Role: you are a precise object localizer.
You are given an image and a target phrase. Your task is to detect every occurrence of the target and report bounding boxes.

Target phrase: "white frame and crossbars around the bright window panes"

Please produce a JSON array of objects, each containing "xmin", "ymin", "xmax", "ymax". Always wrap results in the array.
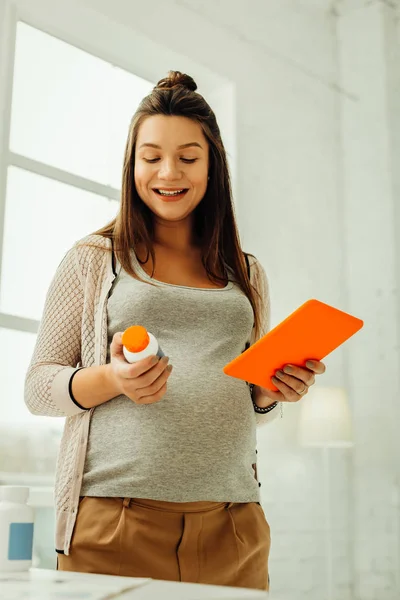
[{"xmin": 0, "ymin": 0, "xmax": 236, "ymax": 333}]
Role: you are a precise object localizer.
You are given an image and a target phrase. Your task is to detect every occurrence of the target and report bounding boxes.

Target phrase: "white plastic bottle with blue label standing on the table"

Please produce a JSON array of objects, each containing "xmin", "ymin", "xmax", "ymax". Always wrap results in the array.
[{"xmin": 0, "ymin": 485, "xmax": 34, "ymax": 573}]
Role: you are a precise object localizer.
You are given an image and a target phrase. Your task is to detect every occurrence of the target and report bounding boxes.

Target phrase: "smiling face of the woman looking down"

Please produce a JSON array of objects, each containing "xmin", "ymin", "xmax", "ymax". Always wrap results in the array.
[{"xmin": 135, "ymin": 115, "xmax": 208, "ymax": 221}]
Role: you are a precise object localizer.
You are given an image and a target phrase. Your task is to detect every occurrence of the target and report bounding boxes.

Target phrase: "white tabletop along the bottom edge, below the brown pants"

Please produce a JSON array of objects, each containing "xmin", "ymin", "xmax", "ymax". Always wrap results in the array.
[{"xmin": 0, "ymin": 569, "xmax": 269, "ymax": 600}]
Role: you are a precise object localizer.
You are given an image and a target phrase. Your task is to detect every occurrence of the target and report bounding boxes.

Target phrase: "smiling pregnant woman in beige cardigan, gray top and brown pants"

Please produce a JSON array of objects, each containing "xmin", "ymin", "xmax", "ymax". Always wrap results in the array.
[{"xmin": 25, "ymin": 72, "xmax": 325, "ymax": 590}]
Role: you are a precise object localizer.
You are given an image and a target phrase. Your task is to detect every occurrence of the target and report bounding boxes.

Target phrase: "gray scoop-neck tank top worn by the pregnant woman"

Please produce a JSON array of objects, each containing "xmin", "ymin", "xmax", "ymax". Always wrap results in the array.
[{"xmin": 81, "ymin": 255, "xmax": 259, "ymax": 502}]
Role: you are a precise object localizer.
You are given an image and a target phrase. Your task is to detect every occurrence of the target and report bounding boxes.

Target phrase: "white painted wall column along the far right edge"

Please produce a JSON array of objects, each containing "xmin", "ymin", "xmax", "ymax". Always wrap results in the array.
[{"xmin": 338, "ymin": 2, "xmax": 400, "ymax": 600}]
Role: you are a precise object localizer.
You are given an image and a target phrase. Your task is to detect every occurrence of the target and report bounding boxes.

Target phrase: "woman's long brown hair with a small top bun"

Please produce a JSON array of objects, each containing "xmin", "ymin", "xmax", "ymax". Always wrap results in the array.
[{"xmin": 95, "ymin": 71, "xmax": 260, "ymax": 332}]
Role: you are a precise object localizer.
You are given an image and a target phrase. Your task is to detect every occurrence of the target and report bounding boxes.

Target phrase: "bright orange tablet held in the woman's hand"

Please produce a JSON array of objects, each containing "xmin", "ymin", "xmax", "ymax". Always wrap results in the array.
[{"xmin": 223, "ymin": 300, "xmax": 364, "ymax": 391}]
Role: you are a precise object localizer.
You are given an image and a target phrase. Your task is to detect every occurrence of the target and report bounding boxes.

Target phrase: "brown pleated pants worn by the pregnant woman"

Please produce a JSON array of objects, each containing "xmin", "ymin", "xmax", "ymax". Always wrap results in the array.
[{"xmin": 58, "ymin": 497, "xmax": 270, "ymax": 590}]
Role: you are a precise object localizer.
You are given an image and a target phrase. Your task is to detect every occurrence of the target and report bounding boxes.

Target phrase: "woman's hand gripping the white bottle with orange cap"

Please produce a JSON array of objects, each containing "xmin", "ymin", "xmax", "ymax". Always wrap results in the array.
[{"xmin": 110, "ymin": 332, "xmax": 172, "ymax": 404}]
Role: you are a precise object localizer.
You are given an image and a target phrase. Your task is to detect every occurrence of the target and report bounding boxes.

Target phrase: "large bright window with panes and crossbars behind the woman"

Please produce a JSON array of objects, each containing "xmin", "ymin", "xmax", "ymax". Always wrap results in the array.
[{"xmin": 0, "ymin": 21, "xmax": 154, "ymax": 427}]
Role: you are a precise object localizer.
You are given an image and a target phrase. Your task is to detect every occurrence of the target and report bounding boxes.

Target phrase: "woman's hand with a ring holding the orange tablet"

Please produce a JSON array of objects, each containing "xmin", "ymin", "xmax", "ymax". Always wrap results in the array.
[{"xmin": 257, "ymin": 360, "xmax": 326, "ymax": 404}]
